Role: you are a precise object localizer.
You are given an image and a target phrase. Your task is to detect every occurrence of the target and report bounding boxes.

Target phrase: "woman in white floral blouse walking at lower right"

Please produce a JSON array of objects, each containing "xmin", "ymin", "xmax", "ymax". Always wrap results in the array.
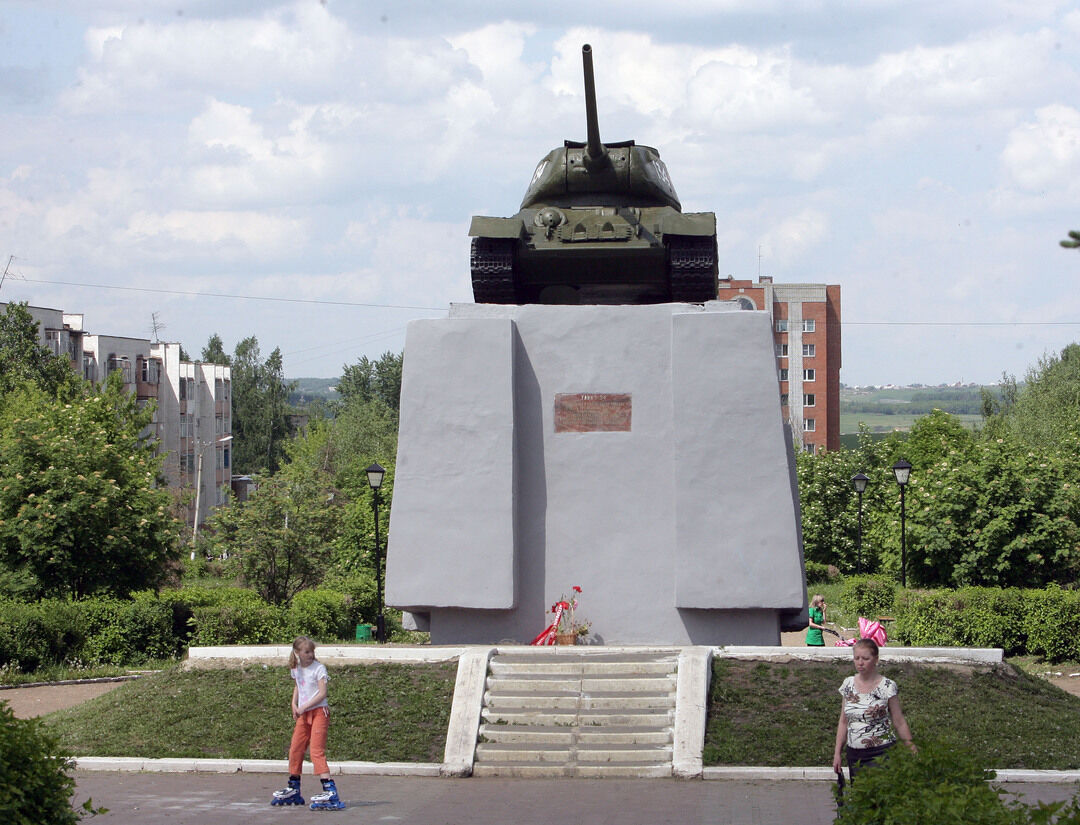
[{"xmin": 833, "ymin": 639, "xmax": 916, "ymax": 780}]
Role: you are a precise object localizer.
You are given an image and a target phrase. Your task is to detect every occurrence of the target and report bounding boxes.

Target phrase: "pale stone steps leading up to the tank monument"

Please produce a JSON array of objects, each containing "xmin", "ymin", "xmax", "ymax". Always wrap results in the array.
[{"xmin": 473, "ymin": 647, "xmax": 678, "ymax": 777}]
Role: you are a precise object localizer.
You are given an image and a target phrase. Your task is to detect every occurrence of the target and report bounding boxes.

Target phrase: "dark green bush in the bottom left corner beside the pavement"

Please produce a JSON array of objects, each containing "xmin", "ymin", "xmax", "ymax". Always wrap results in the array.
[{"xmin": 0, "ymin": 702, "xmax": 105, "ymax": 825}]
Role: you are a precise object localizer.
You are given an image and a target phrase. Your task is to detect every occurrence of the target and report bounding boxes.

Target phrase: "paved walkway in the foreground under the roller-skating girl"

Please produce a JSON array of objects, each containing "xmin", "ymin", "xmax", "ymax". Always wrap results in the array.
[{"xmin": 76, "ymin": 772, "xmax": 1075, "ymax": 825}]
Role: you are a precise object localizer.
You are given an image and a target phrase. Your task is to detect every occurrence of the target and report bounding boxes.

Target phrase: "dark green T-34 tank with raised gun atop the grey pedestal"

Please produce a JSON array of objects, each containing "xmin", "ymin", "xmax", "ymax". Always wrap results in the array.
[{"xmin": 469, "ymin": 44, "xmax": 717, "ymax": 303}]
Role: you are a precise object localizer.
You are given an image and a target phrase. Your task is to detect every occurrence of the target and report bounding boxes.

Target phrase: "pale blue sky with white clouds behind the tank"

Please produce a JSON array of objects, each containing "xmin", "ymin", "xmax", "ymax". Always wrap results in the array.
[{"xmin": 0, "ymin": 0, "xmax": 1080, "ymax": 384}]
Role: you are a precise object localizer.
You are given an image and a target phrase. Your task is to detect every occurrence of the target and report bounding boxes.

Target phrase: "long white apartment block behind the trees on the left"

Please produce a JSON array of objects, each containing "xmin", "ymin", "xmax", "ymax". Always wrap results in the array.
[{"xmin": 0, "ymin": 303, "xmax": 232, "ymax": 527}]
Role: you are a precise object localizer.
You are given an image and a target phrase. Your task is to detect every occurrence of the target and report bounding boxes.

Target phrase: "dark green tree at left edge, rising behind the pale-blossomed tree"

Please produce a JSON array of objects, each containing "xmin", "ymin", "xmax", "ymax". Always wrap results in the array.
[{"xmin": 0, "ymin": 302, "xmax": 79, "ymax": 400}]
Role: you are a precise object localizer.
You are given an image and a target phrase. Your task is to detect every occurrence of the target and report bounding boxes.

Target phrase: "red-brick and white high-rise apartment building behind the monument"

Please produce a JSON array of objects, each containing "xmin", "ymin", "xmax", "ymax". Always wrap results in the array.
[{"xmin": 718, "ymin": 275, "xmax": 840, "ymax": 452}]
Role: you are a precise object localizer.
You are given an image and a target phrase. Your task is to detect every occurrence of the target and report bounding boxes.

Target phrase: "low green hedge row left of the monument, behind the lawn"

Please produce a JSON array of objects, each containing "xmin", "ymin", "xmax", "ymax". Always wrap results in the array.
[{"xmin": 0, "ymin": 581, "xmax": 375, "ymax": 672}]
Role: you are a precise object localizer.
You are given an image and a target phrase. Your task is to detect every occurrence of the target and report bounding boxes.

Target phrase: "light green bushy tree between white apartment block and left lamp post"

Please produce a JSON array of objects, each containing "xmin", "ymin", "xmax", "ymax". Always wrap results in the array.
[{"xmin": 208, "ymin": 463, "xmax": 341, "ymax": 605}]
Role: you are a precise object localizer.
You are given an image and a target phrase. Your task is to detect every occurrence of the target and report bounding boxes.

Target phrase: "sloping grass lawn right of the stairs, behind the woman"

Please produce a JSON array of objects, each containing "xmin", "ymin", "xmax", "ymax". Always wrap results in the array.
[{"xmin": 704, "ymin": 659, "xmax": 1080, "ymax": 770}]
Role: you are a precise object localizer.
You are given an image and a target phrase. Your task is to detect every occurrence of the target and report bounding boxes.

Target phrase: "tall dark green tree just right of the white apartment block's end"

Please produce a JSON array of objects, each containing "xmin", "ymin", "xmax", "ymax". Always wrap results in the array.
[{"xmin": 230, "ymin": 336, "xmax": 292, "ymax": 473}]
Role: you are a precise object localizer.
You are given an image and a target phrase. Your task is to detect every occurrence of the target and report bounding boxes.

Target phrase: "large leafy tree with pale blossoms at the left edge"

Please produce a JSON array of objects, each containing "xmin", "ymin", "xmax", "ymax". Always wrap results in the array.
[{"xmin": 0, "ymin": 374, "xmax": 178, "ymax": 598}]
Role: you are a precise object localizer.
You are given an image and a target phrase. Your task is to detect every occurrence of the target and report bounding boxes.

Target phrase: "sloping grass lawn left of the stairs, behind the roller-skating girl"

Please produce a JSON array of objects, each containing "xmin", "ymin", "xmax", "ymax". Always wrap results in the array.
[{"xmin": 44, "ymin": 662, "xmax": 457, "ymax": 762}]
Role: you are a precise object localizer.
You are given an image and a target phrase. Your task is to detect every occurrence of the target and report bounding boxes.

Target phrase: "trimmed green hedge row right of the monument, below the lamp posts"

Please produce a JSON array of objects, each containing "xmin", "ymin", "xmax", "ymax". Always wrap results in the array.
[{"xmin": 825, "ymin": 576, "xmax": 1080, "ymax": 662}]
